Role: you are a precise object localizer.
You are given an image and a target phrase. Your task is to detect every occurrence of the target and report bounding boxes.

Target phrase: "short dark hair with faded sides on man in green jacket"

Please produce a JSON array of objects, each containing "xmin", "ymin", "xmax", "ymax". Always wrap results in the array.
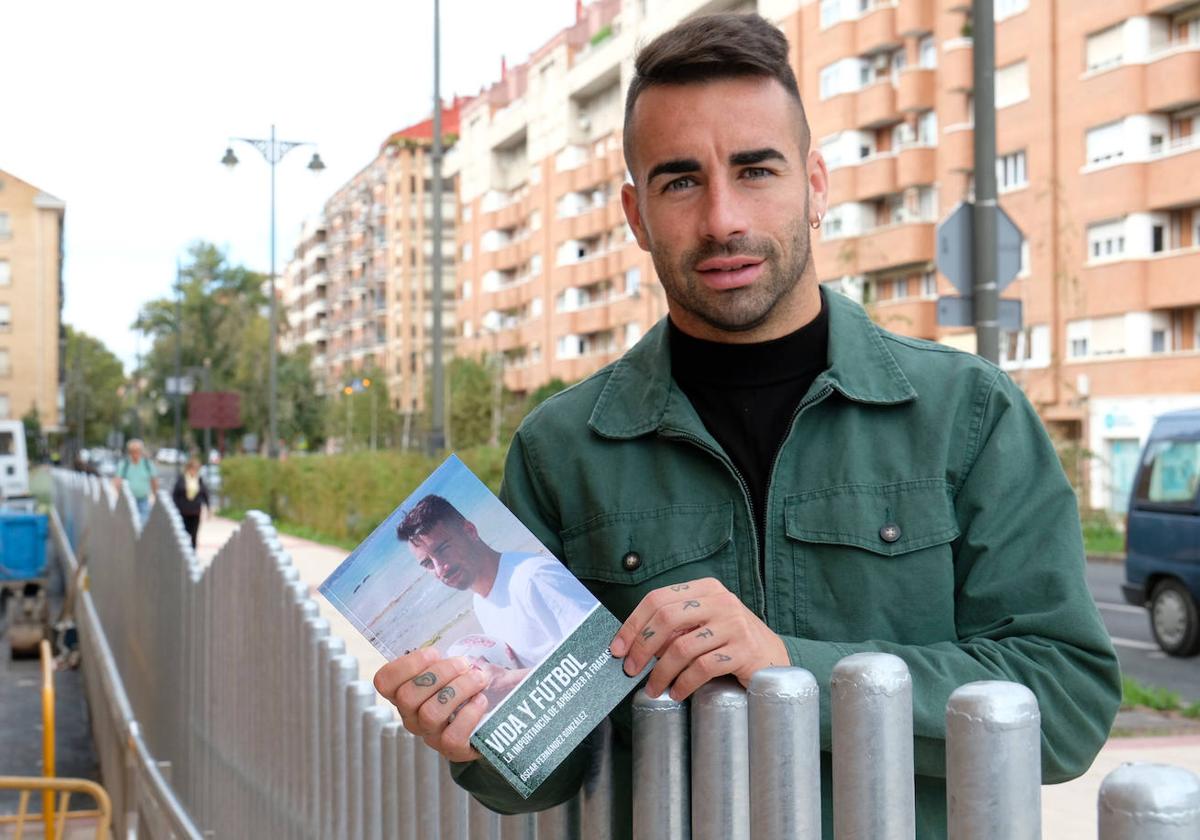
[{"xmin": 624, "ymin": 13, "xmax": 810, "ymax": 172}]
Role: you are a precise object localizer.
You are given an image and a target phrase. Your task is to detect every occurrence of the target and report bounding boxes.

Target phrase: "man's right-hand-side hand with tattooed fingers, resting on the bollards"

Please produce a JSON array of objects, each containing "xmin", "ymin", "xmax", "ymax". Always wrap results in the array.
[{"xmin": 612, "ymin": 577, "xmax": 790, "ymax": 701}]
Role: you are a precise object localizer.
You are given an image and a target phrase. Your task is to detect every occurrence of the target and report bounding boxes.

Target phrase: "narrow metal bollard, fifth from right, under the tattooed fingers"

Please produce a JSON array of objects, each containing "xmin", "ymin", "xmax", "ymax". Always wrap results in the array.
[{"xmin": 691, "ymin": 677, "xmax": 750, "ymax": 840}]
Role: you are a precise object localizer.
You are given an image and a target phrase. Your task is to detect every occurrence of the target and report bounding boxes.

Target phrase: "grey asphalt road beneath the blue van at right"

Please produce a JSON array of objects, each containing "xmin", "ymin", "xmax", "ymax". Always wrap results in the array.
[{"xmin": 1087, "ymin": 562, "xmax": 1200, "ymax": 703}]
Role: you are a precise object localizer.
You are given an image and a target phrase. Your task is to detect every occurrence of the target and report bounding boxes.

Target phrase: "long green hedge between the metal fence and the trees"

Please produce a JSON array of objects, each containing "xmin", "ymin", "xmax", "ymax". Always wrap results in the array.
[{"xmin": 221, "ymin": 446, "xmax": 505, "ymax": 542}]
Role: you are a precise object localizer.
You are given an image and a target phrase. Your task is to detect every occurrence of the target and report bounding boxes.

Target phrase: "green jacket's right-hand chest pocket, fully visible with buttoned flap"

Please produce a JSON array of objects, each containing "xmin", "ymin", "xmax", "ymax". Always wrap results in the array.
[{"xmin": 784, "ymin": 479, "xmax": 959, "ymax": 644}]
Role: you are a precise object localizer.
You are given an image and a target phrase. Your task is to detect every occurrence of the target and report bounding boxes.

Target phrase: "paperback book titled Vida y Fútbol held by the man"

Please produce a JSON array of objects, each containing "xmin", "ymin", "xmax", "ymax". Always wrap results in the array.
[{"xmin": 319, "ymin": 455, "xmax": 649, "ymax": 798}]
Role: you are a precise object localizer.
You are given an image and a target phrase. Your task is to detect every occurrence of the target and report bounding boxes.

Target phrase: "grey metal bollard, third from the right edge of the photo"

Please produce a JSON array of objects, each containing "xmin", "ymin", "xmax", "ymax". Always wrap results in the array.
[{"xmin": 829, "ymin": 653, "xmax": 917, "ymax": 840}]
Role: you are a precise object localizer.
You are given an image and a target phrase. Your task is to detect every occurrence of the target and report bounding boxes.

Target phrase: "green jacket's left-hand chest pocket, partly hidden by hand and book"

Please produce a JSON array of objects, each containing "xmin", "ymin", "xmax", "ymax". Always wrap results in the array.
[{"xmin": 560, "ymin": 502, "xmax": 737, "ymax": 620}]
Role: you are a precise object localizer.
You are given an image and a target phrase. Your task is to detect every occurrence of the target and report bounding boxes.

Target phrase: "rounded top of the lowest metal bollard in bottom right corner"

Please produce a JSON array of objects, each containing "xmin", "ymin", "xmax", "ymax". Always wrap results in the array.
[{"xmin": 1099, "ymin": 764, "xmax": 1200, "ymax": 840}]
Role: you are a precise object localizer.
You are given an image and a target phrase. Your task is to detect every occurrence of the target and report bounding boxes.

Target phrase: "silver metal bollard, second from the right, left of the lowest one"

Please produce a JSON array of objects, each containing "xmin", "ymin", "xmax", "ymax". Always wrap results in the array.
[{"xmin": 946, "ymin": 680, "xmax": 1042, "ymax": 840}]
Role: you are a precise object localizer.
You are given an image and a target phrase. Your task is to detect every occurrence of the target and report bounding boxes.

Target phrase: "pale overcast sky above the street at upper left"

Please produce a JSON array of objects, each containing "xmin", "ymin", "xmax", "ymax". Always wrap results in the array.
[{"xmin": 0, "ymin": 0, "xmax": 575, "ymax": 370}]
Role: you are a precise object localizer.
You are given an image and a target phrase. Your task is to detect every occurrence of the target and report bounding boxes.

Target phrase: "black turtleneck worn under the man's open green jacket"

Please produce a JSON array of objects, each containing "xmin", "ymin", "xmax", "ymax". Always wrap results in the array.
[{"xmin": 670, "ymin": 295, "xmax": 829, "ymax": 564}]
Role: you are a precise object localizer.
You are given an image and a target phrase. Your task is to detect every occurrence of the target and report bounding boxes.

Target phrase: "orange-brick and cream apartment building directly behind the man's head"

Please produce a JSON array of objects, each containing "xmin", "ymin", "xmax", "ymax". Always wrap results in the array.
[{"xmin": 454, "ymin": 0, "xmax": 1200, "ymax": 510}]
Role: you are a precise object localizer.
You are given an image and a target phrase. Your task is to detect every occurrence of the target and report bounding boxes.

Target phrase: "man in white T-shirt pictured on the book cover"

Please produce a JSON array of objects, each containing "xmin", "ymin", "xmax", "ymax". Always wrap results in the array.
[{"xmin": 396, "ymin": 494, "xmax": 595, "ymax": 702}]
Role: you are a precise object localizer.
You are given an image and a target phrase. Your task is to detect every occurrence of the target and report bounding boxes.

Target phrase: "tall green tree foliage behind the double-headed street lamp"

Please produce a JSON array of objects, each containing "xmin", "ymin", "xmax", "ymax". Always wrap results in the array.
[{"xmin": 133, "ymin": 242, "xmax": 325, "ymax": 448}]
